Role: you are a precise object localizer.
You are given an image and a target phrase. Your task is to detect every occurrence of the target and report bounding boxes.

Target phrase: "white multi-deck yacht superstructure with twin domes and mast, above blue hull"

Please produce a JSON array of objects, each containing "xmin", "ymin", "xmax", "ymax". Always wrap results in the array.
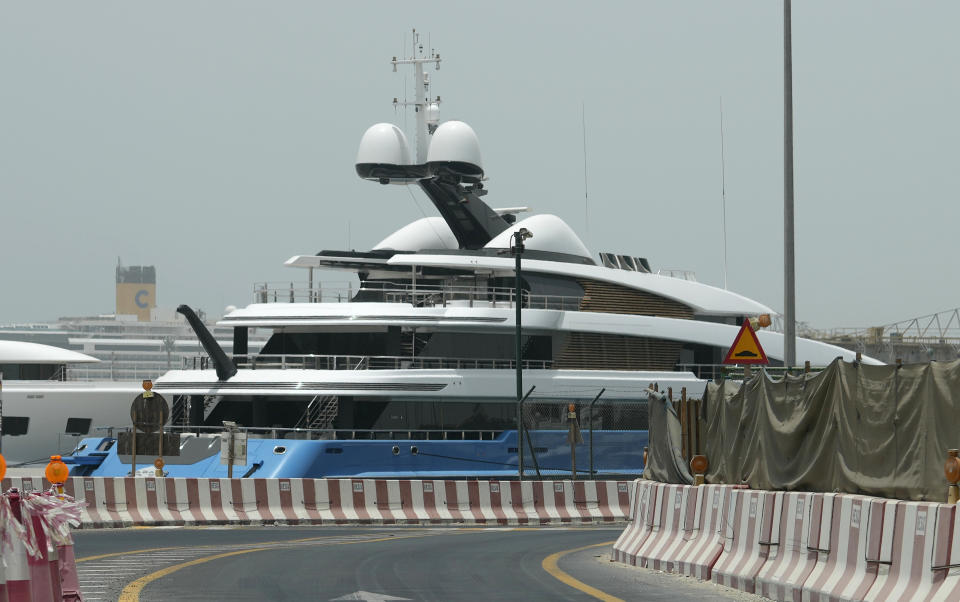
[{"xmin": 156, "ymin": 32, "xmax": 872, "ymax": 446}]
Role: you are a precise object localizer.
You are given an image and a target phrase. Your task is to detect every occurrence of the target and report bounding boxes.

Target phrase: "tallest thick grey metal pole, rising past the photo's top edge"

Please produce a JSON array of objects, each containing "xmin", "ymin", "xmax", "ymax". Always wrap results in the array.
[{"xmin": 783, "ymin": 0, "xmax": 797, "ymax": 368}]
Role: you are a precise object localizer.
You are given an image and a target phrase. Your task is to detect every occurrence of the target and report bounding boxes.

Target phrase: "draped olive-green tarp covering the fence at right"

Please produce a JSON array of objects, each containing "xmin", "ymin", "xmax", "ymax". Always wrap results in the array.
[{"xmin": 649, "ymin": 359, "xmax": 960, "ymax": 501}]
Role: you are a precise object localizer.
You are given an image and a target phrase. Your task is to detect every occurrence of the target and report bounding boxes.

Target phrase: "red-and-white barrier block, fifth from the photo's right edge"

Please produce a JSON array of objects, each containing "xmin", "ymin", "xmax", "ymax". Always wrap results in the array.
[{"xmin": 711, "ymin": 489, "xmax": 775, "ymax": 593}]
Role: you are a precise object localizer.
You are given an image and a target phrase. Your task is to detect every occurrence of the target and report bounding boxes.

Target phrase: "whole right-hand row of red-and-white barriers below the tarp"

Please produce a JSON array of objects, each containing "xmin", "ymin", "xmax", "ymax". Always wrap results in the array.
[{"xmin": 612, "ymin": 481, "xmax": 960, "ymax": 601}]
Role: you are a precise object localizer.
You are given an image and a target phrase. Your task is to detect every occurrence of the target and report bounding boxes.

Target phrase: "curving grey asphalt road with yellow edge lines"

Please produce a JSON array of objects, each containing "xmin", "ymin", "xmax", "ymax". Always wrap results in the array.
[{"xmin": 75, "ymin": 527, "xmax": 760, "ymax": 602}]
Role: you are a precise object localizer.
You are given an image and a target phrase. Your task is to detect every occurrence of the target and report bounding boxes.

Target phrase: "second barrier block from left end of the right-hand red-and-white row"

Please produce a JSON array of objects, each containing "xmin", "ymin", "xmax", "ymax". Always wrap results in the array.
[{"xmin": 636, "ymin": 485, "xmax": 697, "ymax": 572}]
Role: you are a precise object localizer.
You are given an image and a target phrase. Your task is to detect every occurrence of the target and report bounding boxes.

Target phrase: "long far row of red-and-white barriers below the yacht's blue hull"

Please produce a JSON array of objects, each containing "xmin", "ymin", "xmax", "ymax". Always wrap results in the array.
[{"xmin": 3, "ymin": 477, "xmax": 630, "ymax": 528}]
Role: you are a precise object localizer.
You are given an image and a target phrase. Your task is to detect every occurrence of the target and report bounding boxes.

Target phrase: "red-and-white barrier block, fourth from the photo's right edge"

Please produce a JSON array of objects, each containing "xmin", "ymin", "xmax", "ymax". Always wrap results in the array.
[{"xmin": 757, "ymin": 492, "xmax": 820, "ymax": 602}]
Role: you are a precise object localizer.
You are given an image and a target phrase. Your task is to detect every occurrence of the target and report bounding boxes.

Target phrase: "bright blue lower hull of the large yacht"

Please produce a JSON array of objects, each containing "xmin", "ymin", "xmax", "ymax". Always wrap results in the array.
[{"xmin": 64, "ymin": 431, "xmax": 648, "ymax": 479}]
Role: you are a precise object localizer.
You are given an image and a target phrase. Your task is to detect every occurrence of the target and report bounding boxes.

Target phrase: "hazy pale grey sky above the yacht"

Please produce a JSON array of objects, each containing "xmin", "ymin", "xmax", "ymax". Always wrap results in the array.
[{"xmin": 0, "ymin": 0, "xmax": 960, "ymax": 328}]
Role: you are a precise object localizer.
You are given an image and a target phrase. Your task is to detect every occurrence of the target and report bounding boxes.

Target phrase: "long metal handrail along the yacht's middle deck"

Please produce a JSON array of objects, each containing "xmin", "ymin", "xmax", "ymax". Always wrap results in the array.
[{"xmin": 182, "ymin": 354, "xmax": 553, "ymax": 370}]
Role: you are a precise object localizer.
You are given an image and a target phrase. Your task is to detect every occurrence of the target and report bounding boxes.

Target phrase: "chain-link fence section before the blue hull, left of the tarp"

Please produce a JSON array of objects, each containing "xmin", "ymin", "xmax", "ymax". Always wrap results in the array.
[{"xmin": 518, "ymin": 399, "xmax": 648, "ymax": 479}]
